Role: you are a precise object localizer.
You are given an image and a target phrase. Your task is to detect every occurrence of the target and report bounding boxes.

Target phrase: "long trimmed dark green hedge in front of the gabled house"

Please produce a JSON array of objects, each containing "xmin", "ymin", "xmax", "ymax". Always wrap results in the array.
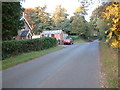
[{"xmin": 2, "ymin": 37, "xmax": 57, "ymax": 60}]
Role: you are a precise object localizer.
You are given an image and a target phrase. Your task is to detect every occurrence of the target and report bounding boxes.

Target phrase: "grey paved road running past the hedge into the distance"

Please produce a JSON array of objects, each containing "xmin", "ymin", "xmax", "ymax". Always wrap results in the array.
[{"xmin": 2, "ymin": 41, "xmax": 100, "ymax": 88}]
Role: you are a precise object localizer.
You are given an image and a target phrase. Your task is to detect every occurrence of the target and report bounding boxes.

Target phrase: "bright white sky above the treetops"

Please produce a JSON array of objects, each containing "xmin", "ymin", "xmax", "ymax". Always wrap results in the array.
[{"xmin": 22, "ymin": 0, "xmax": 99, "ymax": 21}]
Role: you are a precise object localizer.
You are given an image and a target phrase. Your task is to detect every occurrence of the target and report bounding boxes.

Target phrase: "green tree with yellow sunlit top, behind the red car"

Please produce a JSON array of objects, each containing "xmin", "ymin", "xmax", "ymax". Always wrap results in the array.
[{"xmin": 70, "ymin": 7, "xmax": 88, "ymax": 38}]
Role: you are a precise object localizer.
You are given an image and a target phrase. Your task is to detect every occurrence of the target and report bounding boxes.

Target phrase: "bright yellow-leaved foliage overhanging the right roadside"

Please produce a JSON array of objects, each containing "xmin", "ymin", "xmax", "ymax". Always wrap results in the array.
[{"xmin": 91, "ymin": 2, "xmax": 120, "ymax": 48}]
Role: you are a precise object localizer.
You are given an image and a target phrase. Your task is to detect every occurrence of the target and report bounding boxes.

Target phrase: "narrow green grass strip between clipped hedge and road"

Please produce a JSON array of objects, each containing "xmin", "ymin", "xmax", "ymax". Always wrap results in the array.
[{"xmin": 0, "ymin": 46, "xmax": 63, "ymax": 70}]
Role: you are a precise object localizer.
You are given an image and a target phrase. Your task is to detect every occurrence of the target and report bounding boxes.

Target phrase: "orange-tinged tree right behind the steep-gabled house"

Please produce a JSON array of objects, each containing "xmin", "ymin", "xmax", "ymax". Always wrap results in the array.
[{"xmin": 25, "ymin": 6, "xmax": 52, "ymax": 34}]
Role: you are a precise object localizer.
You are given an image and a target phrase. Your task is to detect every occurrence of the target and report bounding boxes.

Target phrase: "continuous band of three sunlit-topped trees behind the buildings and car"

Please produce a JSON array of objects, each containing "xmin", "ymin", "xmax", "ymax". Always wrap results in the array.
[{"xmin": 25, "ymin": 5, "xmax": 94, "ymax": 37}]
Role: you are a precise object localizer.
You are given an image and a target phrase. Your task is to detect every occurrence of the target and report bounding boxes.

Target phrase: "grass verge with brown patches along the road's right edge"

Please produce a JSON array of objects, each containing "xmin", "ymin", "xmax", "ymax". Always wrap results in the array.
[{"xmin": 100, "ymin": 42, "xmax": 118, "ymax": 88}]
